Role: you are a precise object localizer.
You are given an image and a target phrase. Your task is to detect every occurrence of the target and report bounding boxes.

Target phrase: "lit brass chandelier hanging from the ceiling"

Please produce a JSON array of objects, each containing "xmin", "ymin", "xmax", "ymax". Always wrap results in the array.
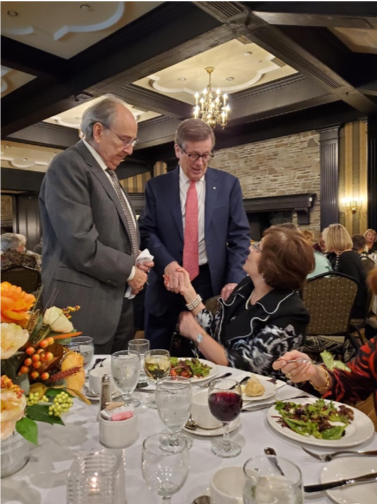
[{"xmin": 194, "ymin": 67, "xmax": 230, "ymax": 129}]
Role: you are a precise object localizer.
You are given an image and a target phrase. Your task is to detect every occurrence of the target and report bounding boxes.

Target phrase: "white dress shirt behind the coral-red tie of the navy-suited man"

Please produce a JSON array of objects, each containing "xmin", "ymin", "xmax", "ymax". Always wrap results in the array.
[{"xmin": 179, "ymin": 167, "xmax": 208, "ymax": 266}]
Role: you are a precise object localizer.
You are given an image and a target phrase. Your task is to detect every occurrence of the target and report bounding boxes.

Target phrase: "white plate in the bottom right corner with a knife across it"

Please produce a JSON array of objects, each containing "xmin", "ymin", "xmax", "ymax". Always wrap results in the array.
[{"xmin": 320, "ymin": 456, "xmax": 377, "ymax": 504}]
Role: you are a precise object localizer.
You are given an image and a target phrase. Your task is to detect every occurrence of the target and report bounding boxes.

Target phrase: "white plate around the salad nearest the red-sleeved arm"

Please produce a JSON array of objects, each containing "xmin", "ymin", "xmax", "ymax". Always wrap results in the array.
[{"xmin": 267, "ymin": 397, "xmax": 377, "ymax": 446}]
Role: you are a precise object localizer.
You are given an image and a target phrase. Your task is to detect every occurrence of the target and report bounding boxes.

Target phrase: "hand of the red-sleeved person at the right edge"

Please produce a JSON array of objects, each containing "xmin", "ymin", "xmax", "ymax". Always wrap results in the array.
[{"xmin": 272, "ymin": 350, "xmax": 322, "ymax": 383}]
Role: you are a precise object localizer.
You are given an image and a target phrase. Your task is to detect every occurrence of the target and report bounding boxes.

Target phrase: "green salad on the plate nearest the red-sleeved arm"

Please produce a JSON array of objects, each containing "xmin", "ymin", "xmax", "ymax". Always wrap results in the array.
[{"xmin": 275, "ymin": 399, "xmax": 353, "ymax": 440}]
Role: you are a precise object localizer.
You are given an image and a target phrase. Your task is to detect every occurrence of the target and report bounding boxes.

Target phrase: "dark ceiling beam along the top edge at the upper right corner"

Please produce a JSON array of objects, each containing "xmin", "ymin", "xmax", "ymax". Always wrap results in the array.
[{"xmin": 241, "ymin": 1, "xmax": 377, "ymax": 29}]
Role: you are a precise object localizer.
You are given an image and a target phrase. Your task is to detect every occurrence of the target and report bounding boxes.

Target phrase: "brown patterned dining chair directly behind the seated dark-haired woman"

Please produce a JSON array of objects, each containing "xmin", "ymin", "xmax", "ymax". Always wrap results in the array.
[{"xmin": 302, "ymin": 271, "xmax": 361, "ymax": 362}]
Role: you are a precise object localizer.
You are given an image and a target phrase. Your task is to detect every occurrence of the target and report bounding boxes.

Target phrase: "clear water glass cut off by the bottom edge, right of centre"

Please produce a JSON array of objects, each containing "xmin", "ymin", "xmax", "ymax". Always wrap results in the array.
[{"xmin": 243, "ymin": 455, "xmax": 304, "ymax": 504}]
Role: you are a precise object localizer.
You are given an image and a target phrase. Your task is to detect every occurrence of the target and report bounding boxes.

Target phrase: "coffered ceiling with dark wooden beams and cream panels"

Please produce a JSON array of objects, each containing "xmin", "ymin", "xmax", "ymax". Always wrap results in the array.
[{"xmin": 0, "ymin": 1, "xmax": 377, "ymax": 189}]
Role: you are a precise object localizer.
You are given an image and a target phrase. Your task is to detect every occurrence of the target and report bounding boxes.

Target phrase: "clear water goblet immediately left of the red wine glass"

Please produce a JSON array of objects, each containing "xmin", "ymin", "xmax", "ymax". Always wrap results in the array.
[{"xmin": 156, "ymin": 376, "xmax": 192, "ymax": 451}]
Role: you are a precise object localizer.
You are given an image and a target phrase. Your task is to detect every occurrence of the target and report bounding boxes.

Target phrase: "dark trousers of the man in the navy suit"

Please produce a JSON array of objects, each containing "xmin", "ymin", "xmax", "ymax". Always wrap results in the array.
[{"xmin": 145, "ymin": 264, "xmax": 214, "ymax": 350}]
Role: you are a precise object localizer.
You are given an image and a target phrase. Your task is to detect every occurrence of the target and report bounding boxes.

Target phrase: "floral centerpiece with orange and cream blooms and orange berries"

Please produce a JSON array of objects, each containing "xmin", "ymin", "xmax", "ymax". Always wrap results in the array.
[{"xmin": 0, "ymin": 282, "xmax": 88, "ymax": 444}]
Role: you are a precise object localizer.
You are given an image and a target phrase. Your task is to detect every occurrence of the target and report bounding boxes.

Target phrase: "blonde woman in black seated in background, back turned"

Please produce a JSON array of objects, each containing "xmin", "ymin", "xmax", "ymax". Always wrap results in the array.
[{"xmin": 323, "ymin": 224, "xmax": 368, "ymax": 318}]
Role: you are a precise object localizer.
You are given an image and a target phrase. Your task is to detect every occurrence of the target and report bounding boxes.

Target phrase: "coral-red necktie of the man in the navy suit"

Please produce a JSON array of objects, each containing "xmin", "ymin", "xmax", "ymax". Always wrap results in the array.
[{"xmin": 183, "ymin": 180, "xmax": 199, "ymax": 281}]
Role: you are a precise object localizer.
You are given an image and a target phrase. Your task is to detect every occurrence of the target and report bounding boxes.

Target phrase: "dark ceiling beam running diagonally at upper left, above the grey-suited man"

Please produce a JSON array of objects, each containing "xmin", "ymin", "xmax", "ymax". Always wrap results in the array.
[{"xmin": 0, "ymin": 1, "xmax": 223, "ymax": 138}]
